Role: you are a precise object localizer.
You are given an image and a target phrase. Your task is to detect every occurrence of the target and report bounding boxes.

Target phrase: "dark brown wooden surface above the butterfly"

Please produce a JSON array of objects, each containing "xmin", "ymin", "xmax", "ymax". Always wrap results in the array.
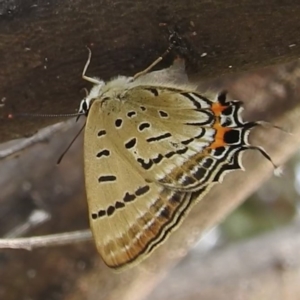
[{"xmin": 0, "ymin": 0, "xmax": 300, "ymax": 142}]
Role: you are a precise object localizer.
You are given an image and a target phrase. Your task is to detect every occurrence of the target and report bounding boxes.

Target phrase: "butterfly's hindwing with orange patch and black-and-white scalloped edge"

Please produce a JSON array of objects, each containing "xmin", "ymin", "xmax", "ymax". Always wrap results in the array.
[{"xmin": 124, "ymin": 86, "xmax": 256, "ymax": 192}]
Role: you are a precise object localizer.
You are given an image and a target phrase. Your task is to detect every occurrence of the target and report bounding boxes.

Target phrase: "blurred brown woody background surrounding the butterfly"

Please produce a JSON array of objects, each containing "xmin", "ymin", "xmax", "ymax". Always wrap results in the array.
[{"xmin": 0, "ymin": 0, "xmax": 300, "ymax": 300}]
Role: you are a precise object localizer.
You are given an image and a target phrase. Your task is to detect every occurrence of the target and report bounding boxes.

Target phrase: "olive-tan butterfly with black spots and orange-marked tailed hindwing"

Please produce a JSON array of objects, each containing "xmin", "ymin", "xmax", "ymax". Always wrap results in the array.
[{"xmin": 79, "ymin": 45, "xmax": 272, "ymax": 269}]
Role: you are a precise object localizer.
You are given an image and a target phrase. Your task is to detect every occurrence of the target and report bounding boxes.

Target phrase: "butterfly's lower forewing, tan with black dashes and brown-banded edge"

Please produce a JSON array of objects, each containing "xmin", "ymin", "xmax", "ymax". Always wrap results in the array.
[{"xmin": 84, "ymin": 101, "xmax": 206, "ymax": 268}]
